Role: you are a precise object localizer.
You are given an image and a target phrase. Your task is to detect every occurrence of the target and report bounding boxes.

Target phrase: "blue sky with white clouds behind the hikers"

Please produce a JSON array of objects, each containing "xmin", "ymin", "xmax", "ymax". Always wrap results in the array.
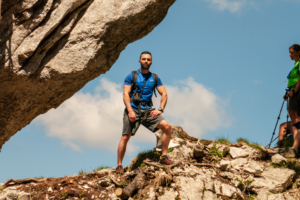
[{"xmin": 0, "ymin": 0, "xmax": 300, "ymax": 182}]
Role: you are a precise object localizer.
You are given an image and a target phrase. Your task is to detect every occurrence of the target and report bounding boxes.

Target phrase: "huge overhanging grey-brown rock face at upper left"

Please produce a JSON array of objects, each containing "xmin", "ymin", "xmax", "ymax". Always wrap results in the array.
[{"xmin": 0, "ymin": 0, "xmax": 175, "ymax": 150}]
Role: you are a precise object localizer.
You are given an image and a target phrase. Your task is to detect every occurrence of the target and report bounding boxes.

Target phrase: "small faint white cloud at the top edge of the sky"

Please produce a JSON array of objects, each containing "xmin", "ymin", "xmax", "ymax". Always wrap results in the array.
[{"xmin": 206, "ymin": 0, "xmax": 248, "ymax": 12}]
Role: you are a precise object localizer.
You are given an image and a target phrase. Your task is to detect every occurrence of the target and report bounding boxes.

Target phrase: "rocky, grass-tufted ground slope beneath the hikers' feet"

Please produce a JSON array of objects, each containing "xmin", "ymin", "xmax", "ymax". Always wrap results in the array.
[{"xmin": 0, "ymin": 126, "xmax": 300, "ymax": 200}]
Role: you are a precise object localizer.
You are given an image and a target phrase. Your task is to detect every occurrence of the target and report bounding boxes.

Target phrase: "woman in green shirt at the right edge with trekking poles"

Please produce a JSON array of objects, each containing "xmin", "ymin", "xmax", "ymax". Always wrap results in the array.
[{"xmin": 284, "ymin": 44, "xmax": 300, "ymax": 158}]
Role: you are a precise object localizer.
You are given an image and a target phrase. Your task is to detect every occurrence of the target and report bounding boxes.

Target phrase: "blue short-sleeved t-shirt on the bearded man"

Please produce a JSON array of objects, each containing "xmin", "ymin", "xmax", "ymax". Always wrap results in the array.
[{"xmin": 124, "ymin": 70, "xmax": 163, "ymax": 110}]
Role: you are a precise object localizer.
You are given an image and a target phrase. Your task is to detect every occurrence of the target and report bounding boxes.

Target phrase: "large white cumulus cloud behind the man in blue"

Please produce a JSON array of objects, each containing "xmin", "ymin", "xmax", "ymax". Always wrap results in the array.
[{"xmin": 35, "ymin": 78, "xmax": 231, "ymax": 152}]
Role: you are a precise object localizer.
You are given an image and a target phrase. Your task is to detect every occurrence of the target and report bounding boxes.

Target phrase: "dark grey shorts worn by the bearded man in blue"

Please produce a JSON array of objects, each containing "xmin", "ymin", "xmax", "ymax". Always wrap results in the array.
[{"xmin": 122, "ymin": 109, "xmax": 164, "ymax": 136}]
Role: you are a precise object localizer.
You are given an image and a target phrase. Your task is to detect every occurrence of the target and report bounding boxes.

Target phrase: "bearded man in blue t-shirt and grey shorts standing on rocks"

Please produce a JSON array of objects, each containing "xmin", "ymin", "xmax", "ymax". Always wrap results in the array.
[{"xmin": 116, "ymin": 51, "xmax": 173, "ymax": 174}]
